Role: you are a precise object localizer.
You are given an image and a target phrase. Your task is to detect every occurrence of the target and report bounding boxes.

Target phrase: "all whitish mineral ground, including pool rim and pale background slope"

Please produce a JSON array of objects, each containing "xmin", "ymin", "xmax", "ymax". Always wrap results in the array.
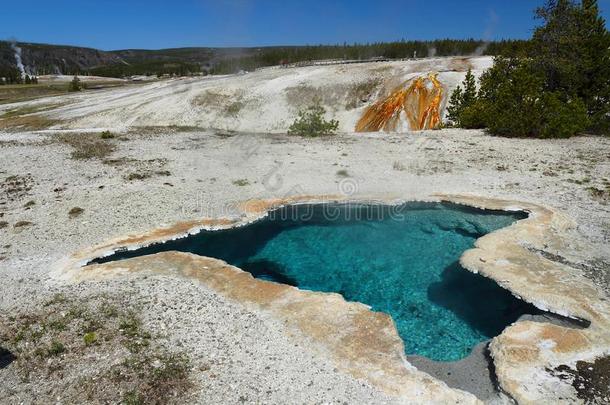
[{"xmin": 0, "ymin": 58, "xmax": 610, "ymax": 403}]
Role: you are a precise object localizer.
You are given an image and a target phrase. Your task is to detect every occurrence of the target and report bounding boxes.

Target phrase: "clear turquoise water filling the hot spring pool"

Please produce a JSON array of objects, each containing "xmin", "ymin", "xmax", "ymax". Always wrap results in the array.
[{"xmin": 92, "ymin": 203, "xmax": 535, "ymax": 361}]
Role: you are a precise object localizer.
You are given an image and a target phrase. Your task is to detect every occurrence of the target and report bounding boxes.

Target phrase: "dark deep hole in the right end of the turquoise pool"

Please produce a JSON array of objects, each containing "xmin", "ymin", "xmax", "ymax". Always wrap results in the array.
[{"xmin": 428, "ymin": 262, "xmax": 541, "ymax": 338}]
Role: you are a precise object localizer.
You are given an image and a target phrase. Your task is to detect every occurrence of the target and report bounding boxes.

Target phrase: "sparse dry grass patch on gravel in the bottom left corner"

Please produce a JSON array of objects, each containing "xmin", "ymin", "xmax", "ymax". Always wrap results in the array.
[{"xmin": 0, "ymin": 294, "xmax": 193, "ymax": 404}]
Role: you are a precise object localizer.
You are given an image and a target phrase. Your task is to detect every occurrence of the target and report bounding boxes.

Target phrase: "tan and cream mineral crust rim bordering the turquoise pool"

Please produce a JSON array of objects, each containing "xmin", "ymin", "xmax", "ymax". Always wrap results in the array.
[{"xmin": 51, "ymin": 194, "xmax": 610, "ymax": 403}]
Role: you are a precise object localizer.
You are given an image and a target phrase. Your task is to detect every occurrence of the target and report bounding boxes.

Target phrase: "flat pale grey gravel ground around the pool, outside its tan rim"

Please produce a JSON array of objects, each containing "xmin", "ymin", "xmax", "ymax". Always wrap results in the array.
[{"xmin": 0, "ymin": 130, "xmax": 610, "ymax": 403}]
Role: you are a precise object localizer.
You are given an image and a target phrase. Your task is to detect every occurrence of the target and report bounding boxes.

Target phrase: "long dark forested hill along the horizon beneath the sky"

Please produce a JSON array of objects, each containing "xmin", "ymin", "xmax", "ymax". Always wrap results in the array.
[{"xmin": 0, "ymin": 39, "xmax": 529, "ymax": 77}]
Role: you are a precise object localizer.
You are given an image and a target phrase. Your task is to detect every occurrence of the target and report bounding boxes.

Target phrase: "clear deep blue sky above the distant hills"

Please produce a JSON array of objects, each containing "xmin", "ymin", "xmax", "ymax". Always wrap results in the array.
[{"xmin": 0, "ymin": 0, "xmax": 610, "ymax": 50}]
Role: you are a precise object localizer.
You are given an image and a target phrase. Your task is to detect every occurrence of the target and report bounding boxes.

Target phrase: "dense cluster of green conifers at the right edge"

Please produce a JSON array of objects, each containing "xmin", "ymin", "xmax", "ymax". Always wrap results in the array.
[{"xmin": 447, "ymin": 0, "xmax": 610, "ymax": 138}]
